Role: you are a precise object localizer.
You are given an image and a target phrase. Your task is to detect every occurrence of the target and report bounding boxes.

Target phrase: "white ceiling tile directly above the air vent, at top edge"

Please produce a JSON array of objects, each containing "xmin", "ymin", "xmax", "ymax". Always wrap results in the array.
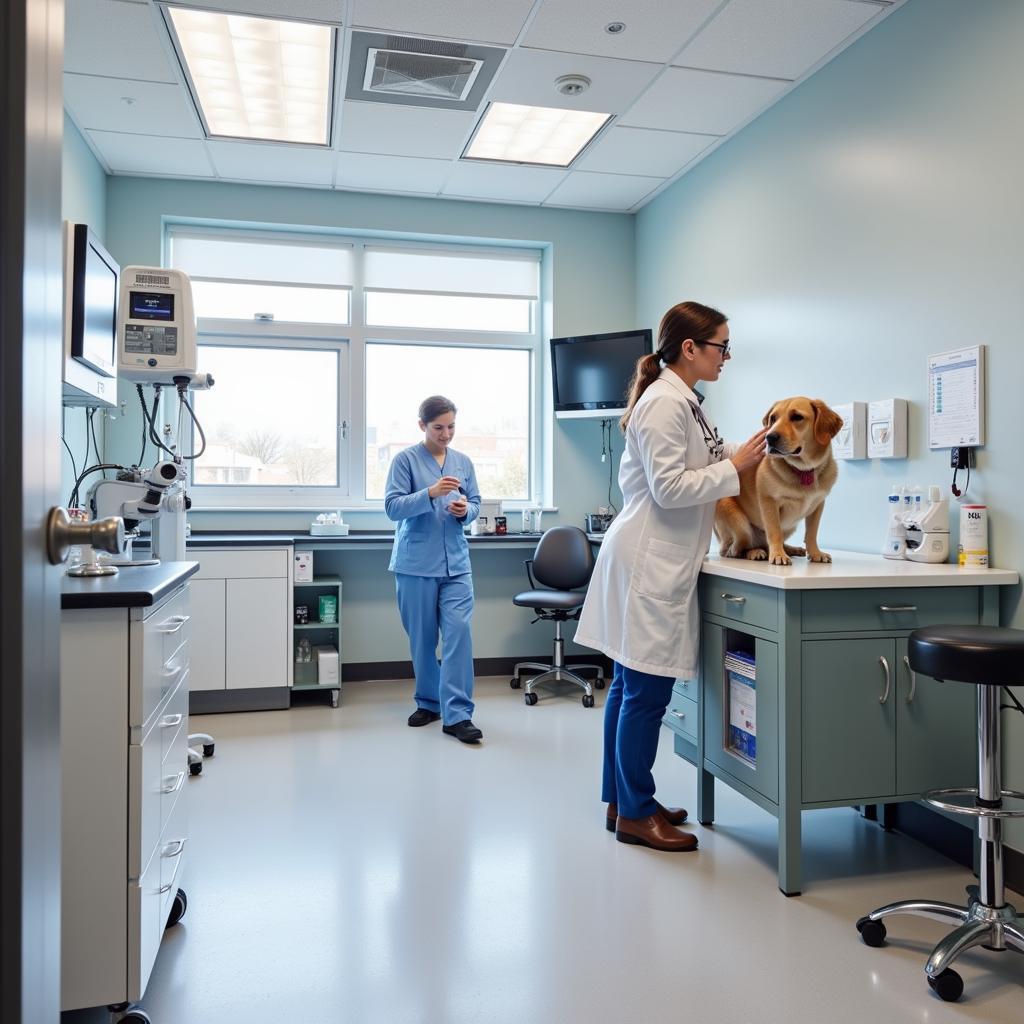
[{"xmin": 352, "ymin": 0, "xmax": 534, "ymax": 46}]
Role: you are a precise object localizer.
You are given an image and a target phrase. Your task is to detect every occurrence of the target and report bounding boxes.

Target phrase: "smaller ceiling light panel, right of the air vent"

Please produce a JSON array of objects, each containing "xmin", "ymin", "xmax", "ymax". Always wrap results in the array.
[{"xmin": 463, "ymin": 103, "xmax": 611, "ymax": 167}]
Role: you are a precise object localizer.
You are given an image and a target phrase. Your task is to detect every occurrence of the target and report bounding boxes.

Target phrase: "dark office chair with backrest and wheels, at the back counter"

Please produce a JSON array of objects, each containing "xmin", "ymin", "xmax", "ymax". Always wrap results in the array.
[{"xmin": 509, "ymin": 526, "xmax": 604, "ymax": 708}]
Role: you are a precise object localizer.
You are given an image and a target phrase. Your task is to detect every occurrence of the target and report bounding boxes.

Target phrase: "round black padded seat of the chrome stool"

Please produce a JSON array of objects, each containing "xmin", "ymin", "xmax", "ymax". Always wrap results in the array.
[{"xmin": 907, "ymin": 626, "xmax": 1024, "ymax": 686}]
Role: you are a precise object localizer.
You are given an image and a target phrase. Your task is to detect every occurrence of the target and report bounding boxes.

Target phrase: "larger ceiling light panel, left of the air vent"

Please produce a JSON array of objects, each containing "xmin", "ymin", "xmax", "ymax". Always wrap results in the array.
[{"xmin": 167, "ymin": 7, "xmax": 334, "ymax": 145}]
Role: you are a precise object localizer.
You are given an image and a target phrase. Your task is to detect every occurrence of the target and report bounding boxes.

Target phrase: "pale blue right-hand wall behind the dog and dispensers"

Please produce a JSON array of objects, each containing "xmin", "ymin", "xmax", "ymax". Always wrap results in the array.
[{"xmin": 637, "ymin": 0, "xmax": 1024, "ymax": 849}]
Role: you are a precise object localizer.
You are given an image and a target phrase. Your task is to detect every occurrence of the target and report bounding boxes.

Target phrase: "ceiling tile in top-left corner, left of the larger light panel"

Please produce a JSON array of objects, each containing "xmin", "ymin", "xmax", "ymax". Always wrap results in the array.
[{"xmin": 63, "ymin": 0, "xmax": 178, "ymax": 83}]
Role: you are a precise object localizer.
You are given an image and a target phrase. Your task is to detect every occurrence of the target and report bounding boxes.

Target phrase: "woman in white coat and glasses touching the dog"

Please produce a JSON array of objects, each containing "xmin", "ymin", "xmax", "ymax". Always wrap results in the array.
[{"xmin": 575, "ymin": 302, "xmax": 766, "ymax": 851}]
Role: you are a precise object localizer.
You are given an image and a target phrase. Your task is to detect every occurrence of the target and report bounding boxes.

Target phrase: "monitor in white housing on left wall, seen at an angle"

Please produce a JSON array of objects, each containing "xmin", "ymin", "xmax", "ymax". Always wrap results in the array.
[{"xmin": 63, "ymin": 221, "xmax": 121, "ymax": 404}]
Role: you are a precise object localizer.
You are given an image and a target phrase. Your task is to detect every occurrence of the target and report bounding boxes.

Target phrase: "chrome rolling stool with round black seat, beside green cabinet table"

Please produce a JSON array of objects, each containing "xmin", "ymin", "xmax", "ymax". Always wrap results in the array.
[{"xmin": 857, "ymin": 626, "xmax": 1024, "ymax": 1002}]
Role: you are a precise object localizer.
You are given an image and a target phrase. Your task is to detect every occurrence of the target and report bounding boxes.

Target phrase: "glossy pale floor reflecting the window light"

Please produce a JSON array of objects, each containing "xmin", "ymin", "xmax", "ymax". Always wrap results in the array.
[{"xmin": 70, "ymin": 679, "xmax": 1024, "ymax": 1024}]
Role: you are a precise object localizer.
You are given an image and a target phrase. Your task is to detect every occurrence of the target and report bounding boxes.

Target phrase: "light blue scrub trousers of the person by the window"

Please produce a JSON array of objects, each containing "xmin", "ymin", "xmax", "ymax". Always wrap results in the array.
[{"xmin": 394, "ymin": 572, "xmax": 473, "ymax": 725}]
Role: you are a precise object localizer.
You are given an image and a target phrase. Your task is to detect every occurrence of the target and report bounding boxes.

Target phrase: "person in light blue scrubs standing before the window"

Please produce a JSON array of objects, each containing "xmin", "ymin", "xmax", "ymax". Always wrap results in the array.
[{"xmin": 384, "ymin": 395, "xmax": 483, "ymax": 743}]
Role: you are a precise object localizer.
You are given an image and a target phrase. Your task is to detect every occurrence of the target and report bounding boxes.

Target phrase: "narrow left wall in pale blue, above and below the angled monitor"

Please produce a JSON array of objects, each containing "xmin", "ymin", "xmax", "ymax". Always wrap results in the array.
[{"xmin": 60, "ymin": 115, "xmax": 106, "ymax": 501}]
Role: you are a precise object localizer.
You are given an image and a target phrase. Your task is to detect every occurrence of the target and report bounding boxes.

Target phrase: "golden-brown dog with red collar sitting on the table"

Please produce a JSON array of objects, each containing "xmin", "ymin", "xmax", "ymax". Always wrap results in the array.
[{"xmin": 715, "ymin": 396, "xmax": 843, "ymax": 565}]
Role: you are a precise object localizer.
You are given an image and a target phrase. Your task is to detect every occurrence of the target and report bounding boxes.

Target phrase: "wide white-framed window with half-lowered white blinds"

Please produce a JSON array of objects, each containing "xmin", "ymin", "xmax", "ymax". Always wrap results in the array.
[{"xmin": 168, "ymin": 225, "xmax": 541, "ymax": 508}]
